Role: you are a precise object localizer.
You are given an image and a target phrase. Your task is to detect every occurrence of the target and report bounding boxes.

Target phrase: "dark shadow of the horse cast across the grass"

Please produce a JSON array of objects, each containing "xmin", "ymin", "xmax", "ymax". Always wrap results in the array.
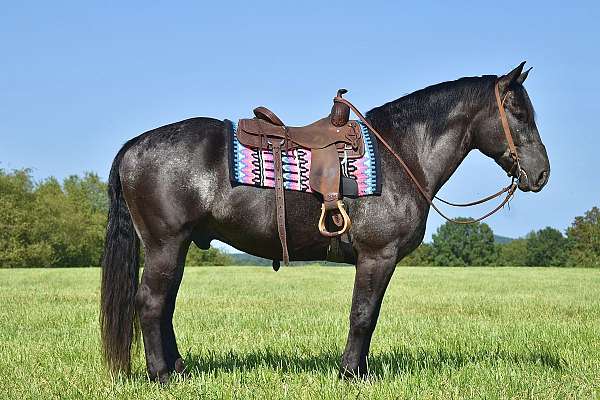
[{"xmin": 180, "ymin": 347, "xmax": 567, "ymax": 377}]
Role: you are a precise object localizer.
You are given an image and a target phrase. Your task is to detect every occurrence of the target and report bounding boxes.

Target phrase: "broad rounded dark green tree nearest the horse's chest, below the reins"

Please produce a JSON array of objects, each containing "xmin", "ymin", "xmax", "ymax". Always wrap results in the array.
[{"xmin": 431, "ymin": 218, "xmax": 498, "ymax": 266}]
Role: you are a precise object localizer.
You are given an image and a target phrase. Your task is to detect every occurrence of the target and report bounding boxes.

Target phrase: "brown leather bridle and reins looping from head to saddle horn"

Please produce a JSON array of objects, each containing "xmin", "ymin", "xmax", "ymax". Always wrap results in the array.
[{"xmin": 333, "ymin": 81, "xmax": 523, "ymax": 224}]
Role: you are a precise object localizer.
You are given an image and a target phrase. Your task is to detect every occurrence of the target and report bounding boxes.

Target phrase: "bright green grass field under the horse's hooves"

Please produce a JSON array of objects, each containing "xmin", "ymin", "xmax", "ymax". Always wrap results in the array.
[{"xmin": 0, "ymin": 267, "xmax": 600, "ymax": 400}]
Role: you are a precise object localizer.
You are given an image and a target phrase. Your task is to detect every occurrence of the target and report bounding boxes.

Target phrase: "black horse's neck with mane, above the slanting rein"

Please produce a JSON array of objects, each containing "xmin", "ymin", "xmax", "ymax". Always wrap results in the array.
[{"xmin": 368, "ymin": 83, "xmax": 485, "ymax": 197}]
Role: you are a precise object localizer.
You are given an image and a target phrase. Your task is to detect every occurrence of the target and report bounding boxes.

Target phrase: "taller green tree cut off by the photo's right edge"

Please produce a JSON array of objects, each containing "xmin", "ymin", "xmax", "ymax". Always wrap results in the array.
[{"xmin": 567, "ymin": 207, "xmax": 600, "ymax": 267}]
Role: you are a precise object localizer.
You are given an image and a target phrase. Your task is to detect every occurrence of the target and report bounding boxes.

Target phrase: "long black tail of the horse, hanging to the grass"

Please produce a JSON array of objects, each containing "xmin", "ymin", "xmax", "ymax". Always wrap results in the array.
[{"xmin": 100, "ymin": 140, "xmax": 140, "ymax": 374}]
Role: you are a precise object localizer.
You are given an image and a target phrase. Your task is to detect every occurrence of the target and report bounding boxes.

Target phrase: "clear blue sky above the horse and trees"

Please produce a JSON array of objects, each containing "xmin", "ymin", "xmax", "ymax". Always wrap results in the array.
[{"xmin": 0, "ymin": 1, "xmax": 600, "ymax": 248}]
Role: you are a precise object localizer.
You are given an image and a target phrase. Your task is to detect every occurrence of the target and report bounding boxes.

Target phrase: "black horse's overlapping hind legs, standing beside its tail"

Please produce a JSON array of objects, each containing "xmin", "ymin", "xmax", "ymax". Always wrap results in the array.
[{"xmin": 136, "ymin": 239, "xmax": 189, "ymax": 383}]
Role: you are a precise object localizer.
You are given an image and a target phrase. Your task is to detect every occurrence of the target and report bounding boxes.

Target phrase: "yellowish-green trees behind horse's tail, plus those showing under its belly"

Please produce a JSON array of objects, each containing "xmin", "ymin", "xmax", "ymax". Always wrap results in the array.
[{"xmin": 0, "ymin": 169, "xmax": 233, "ymax": 268}]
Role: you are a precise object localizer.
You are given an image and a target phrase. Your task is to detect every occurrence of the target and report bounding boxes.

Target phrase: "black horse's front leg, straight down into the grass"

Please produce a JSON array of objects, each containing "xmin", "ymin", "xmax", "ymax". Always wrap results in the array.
[{"xmin": 340, "ymin": 248, "xmax": 396, "ymax": 377}]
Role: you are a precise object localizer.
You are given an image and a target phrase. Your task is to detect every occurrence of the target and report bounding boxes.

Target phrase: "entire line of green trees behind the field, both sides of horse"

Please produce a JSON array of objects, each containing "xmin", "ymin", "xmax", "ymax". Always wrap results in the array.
[{"xmin": 0, "ymin": 169, "xmax": 600, "ymax": 268}]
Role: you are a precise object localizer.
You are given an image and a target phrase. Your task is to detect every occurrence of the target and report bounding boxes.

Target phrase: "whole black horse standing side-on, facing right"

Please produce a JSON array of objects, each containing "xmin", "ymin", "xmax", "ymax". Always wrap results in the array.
[{"xmin": 100, "ymin": 63, "xmax": 550, "ymax": 382}]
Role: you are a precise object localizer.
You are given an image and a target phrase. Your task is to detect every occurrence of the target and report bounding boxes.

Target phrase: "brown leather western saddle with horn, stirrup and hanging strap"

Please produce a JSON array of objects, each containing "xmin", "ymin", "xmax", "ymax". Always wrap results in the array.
[{"xmin": 237, "ymin": 89, "xmax": 365, "ymax": 267}]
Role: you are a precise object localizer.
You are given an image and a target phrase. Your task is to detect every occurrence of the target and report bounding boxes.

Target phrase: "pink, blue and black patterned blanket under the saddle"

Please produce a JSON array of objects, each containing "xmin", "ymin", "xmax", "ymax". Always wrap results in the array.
[{"xmin": 229, "ymin": 123, "xmax": 381, "ymax": 197}]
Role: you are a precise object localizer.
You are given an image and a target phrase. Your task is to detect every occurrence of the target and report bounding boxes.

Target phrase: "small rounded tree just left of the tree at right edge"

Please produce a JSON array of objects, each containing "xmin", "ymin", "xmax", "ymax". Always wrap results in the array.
[{"xmin": 527, "ymin": 226, "xmax": 567, "ymax": 267}]
